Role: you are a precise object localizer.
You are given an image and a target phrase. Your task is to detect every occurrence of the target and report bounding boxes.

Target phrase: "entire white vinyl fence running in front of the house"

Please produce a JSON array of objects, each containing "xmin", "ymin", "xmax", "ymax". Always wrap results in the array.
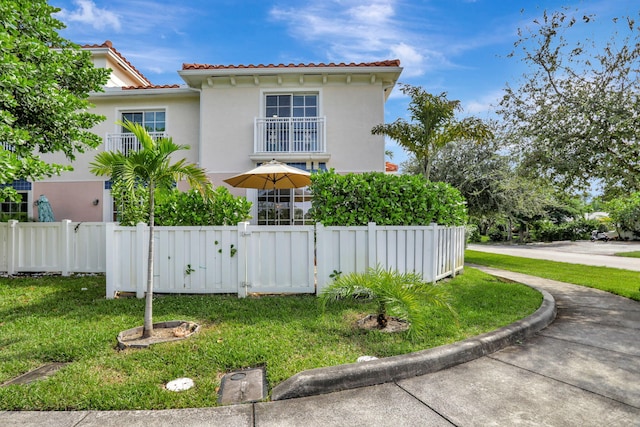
[{"xmin": 0, "ymin": 220, "xmax": 465, "ymax": 298}]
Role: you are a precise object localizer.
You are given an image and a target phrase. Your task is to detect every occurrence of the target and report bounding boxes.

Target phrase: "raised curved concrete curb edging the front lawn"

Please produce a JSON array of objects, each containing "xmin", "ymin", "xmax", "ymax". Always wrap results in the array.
[{"xmin": 271, "ymin": 285, "xmax": 557, "ymax": 400}]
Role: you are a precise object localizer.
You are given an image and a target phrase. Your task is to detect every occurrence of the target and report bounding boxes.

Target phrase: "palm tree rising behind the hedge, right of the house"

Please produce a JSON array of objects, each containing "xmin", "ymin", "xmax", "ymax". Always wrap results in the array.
[{"xmin": 371, "ymin": 84, "xmax": 493, "ymax": 179}]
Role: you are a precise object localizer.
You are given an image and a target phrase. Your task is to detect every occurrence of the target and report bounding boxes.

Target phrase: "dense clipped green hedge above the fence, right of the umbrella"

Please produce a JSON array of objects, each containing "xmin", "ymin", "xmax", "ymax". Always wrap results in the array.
[{"xmin": 310, "ymin": 170, "xmax": 467, "ymax": 226}]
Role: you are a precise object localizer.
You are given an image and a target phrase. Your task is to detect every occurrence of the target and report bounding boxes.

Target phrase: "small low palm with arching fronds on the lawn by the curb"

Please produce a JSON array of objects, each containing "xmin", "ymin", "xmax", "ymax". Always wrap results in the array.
[{"xmin": 320, "ymin": 266, "xmax": 457, "ymax": 337}]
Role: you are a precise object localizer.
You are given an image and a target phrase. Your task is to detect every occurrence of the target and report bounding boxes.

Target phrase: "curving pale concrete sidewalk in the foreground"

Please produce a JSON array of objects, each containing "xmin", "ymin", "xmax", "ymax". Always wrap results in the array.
[{"xmin": 0, "ymin": 267, "xmax": 640, "ymax": 427}]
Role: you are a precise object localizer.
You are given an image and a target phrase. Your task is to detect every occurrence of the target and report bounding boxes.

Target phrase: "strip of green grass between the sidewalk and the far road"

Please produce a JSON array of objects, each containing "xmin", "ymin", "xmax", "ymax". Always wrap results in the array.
[{"xmin": 464, "ymin": 250, "xmax": 640, "ymax": 301}]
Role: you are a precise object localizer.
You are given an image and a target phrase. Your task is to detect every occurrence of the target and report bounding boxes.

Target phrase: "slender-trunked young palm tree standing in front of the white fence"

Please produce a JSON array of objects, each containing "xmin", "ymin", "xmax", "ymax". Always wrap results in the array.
[{"xmin": 91, "ymin": 121, "xmax": 211, "ymax": 338}]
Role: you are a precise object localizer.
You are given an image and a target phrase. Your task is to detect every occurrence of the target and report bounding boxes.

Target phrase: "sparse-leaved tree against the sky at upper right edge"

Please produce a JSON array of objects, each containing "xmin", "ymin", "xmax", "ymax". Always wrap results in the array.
[{"xmin": 499, "ymin": 9, "xmax": 640, "ymax": 194}]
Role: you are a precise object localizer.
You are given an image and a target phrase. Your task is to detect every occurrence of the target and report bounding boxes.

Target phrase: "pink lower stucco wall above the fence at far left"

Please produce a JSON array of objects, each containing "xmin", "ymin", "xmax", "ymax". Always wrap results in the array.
[{"xmin": 33, "ymin": 181, "xmax": 104, "ymax": 222}]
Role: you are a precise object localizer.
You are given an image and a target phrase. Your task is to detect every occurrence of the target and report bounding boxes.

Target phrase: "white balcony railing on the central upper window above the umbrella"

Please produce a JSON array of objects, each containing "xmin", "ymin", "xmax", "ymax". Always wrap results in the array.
[{"xmin": 254, "ymin": 117, "xmax": 326, "ymax": 153}]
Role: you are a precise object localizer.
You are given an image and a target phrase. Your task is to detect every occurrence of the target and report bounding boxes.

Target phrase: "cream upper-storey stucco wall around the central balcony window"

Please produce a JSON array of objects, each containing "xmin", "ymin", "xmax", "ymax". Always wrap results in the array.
[{"xmin": 201, "ymin": 79, "xmax": 384, "ymax": 181}]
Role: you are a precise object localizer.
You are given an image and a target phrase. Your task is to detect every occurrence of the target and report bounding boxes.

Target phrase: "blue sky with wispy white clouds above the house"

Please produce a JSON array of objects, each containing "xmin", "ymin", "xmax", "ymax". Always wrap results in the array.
[{"xmin": 50, "ymin": 0, "xmax": 639, "ymax": 163}]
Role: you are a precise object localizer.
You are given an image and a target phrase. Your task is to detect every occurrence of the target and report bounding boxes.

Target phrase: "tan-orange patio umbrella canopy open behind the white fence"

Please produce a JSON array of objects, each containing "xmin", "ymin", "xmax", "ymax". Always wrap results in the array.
[{"xmin": 224, "ymin": 160, "xmax": 311, "ymax": 190}]
